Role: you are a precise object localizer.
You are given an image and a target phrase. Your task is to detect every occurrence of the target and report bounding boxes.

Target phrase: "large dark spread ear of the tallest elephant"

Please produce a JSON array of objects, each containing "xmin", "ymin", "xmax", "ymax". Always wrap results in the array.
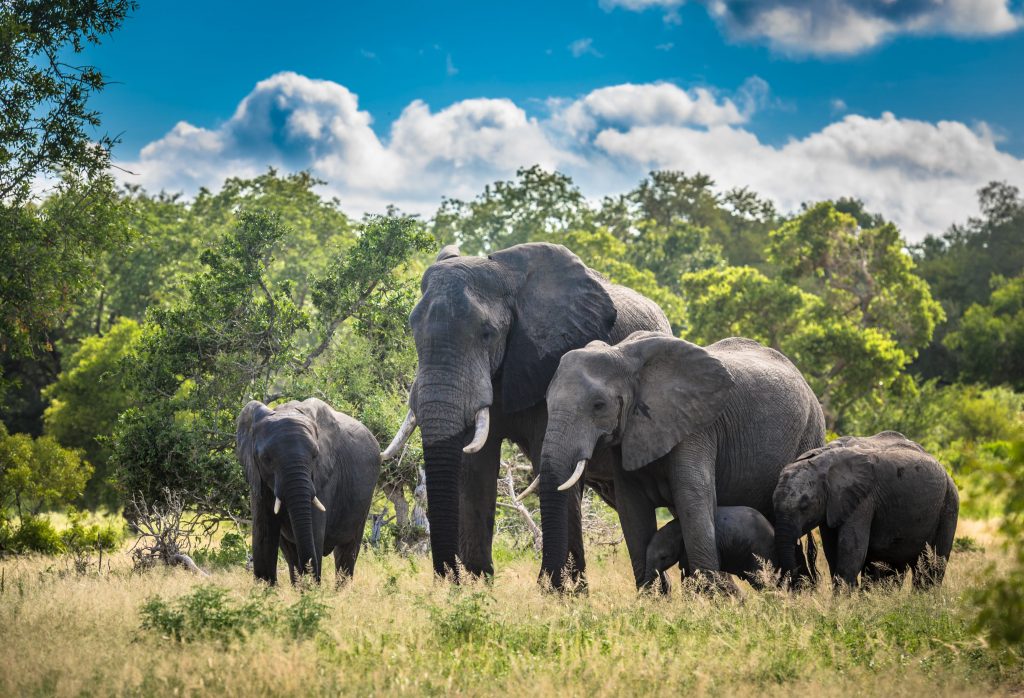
[{"xmin": 489, "ymin": 243, "xmax": 616, "ymax": 412}]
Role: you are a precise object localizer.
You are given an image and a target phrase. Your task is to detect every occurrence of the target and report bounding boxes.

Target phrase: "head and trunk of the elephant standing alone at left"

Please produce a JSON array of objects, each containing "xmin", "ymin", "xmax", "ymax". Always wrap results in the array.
[{"xmin": 236, "ymin": 400, "xmax": 325, "ymax": 581}]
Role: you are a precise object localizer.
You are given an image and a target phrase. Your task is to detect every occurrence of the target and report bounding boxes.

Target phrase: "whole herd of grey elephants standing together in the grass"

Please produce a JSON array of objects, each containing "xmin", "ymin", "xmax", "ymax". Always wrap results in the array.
[{"xmin": 237, "ymin": 243, "xmax": 959, "ymax": 592}]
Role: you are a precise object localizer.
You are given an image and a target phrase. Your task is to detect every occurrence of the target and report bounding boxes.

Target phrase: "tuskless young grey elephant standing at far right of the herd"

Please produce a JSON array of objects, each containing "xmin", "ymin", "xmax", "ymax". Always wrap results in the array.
[{"xmin": 774, "ymin": 432, "xmax": 959, "ymax": 587}]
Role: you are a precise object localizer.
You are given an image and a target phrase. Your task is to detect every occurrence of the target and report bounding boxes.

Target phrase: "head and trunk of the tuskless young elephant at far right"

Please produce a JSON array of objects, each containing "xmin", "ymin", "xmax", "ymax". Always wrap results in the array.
[{"xmin": 772, "ymin": 437, "xmax": 874, "ymax": 581}]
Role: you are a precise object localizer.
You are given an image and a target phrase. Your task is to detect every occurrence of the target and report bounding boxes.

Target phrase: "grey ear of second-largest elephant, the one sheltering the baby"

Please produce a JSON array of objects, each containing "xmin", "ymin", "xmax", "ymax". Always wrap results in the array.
[{"xmin": 616, "ymin": 332, "xmax": 733, "ymax": 470}]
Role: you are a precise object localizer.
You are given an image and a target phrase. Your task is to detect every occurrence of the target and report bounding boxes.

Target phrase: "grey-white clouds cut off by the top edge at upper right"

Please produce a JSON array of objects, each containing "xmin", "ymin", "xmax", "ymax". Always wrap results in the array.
[{"xmin": 599, "ymin": 0, "xmax": 1024, "ymax": 55}]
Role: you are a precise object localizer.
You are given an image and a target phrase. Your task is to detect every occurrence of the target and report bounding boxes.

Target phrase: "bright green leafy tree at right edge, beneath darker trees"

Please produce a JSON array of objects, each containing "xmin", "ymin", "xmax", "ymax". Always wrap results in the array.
[{"xmin": 943, "ymin": 274, "xmax": 1024, "ymax": 390}]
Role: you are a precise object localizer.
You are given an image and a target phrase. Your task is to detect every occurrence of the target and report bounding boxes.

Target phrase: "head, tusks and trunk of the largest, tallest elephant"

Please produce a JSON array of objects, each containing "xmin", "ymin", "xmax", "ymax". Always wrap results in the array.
[{"xmin": 385, "ymin": 243, "xmax": 616, "ymax": 574}]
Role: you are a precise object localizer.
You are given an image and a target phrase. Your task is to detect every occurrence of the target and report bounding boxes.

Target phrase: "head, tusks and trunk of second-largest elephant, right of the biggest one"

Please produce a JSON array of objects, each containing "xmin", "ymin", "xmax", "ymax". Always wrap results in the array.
[{"xmin": 540, "ymin": 332, "xmax": 733, "ymax": 587}]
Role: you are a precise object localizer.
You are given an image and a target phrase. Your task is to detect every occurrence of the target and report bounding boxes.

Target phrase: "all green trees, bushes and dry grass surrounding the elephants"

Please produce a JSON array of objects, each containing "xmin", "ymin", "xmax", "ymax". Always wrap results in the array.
[{"xmin": 0, "ymin": 0, "xmax": 1024, "ymax": 695}]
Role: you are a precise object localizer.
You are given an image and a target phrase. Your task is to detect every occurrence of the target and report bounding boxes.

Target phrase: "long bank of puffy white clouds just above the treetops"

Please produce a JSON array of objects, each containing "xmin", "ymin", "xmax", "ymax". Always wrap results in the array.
[{"xmin": 118, "ymin": 73, "xmax": 1024, "ymax": 238}]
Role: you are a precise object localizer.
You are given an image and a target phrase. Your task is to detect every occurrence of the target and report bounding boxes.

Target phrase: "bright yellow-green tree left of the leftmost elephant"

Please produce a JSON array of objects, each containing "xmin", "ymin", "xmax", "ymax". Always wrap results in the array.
[{"xmin": 44, "ymin": 318, "xmax": 139, "ymax": 507}]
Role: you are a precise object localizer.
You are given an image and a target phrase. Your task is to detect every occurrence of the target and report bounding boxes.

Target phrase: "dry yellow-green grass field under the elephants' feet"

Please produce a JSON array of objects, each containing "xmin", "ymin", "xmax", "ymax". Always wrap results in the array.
[{"xmin": 0, "ymin": 522, "xmax": 1024, "ymax": 696}]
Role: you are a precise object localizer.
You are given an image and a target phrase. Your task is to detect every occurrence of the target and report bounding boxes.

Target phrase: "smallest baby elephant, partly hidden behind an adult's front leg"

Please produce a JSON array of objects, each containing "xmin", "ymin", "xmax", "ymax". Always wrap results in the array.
[{"xmin": 644, "ymin": 507, "xmax": 810, "ymax": 590}]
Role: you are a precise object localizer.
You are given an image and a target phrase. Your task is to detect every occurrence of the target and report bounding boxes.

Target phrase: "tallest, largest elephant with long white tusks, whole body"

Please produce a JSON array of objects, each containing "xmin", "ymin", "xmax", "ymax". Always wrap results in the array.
[{"xmin": 384, "ymin": 243, "xmax": 671, "ymax": 575}]
